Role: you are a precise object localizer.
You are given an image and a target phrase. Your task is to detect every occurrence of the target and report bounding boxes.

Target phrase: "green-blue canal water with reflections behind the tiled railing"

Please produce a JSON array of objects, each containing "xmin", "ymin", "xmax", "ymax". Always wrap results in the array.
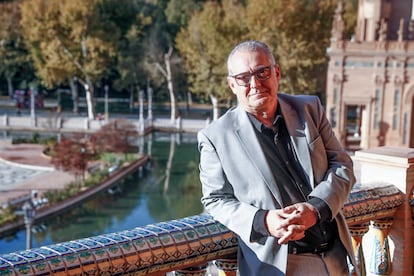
[{"xmin": 0, "ymin": 133, "xmax": 203, "ymax": 254}]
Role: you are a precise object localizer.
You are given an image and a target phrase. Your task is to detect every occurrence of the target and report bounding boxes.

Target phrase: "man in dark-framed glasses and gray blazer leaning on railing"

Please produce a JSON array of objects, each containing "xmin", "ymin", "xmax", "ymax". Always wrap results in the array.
[{"xmin": 198, "ymin": 41, "xmax": 355, "ymax": 276}]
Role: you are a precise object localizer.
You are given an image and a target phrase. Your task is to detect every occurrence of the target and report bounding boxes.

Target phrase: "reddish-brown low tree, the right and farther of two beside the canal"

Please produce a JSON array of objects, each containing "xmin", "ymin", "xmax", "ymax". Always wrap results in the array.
[{"xmin": 90, "ymin": 119, "xmax": 138, "ymax": 154}]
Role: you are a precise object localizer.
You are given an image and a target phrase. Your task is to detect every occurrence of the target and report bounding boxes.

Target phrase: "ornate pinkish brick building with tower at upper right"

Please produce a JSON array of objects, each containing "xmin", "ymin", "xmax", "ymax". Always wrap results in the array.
[{"xmin": 326, "ymin": 0, "xmax": 414, "ymax": 149}]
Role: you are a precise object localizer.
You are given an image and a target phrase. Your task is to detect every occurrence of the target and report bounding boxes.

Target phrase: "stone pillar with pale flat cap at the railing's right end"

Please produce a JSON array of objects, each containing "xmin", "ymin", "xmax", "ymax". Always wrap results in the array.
[{"xmin": 355, "ymin": 147, "xmax": 414, "ymax": 275}]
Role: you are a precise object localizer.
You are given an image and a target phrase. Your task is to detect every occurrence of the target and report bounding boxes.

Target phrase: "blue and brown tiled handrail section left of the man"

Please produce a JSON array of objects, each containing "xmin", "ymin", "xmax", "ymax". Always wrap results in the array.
[{"xmin": 0, "ymin": 214, "xmax": 238, "ymax": 276}]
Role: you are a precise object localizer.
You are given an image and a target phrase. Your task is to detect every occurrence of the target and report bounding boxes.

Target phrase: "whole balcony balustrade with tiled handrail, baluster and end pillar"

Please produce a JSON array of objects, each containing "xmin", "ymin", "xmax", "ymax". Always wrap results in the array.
[{"xmin": 0, "ymin": 148, "xmax": 414, "ymax": 275}]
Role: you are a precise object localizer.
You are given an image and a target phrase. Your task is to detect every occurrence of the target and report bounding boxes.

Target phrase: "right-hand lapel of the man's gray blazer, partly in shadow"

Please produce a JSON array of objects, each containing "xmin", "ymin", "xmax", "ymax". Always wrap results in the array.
[{"xmin": 279, "ymin": 98, "xmax": 314, "ymax": 187}]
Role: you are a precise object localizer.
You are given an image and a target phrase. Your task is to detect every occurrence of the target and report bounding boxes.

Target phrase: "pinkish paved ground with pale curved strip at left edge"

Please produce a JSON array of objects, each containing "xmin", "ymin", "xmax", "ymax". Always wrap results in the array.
[{"xmin": 0, "ymin": 143, "xmax": 74, "ymax": 206}]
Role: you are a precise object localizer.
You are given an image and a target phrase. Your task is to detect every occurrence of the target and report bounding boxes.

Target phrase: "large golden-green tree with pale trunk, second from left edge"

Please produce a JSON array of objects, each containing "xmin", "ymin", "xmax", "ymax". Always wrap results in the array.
[{"xmin": 21, "ymin": 0, "xmax": 119, "ymax": 119}]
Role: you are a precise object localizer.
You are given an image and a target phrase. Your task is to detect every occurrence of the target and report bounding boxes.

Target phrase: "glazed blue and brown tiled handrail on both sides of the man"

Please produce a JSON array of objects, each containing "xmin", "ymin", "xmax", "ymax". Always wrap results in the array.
[{"xmin": 0, "ymin": 185, "xmax": 404, "ymax": 275}]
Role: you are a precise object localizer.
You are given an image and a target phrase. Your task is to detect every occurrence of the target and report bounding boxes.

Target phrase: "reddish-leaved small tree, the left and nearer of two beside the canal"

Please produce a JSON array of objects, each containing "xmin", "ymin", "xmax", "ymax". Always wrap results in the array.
[{"xmin": 51, "ymin": 137, "xmax": 96, "ymax": 183}]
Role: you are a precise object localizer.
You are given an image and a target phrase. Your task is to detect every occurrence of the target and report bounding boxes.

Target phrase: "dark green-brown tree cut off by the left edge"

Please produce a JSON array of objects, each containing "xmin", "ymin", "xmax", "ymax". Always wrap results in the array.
[{"xmin": 0, "ymin": 0, "xmax": 33, "ymax": 96}]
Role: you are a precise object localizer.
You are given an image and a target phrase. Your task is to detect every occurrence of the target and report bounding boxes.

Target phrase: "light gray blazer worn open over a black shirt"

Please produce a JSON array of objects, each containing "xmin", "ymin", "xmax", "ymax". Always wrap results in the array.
[{"xmin": 198, "ymin": 93, "xmax": 355, "ymax": 275}]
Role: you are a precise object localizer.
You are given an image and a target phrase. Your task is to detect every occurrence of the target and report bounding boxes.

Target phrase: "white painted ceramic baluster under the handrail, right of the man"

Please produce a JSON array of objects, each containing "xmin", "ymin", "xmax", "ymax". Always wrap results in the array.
[{"xmin": 370, "ymin": 218, "xmax": 393, "ymax": 275}]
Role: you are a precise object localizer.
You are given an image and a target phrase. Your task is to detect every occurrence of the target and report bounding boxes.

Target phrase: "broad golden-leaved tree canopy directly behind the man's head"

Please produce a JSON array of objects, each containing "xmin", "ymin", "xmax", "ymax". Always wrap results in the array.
[{"xmin": 176, "ymin": 0, "xmax": 357, "ymax": 104}]
